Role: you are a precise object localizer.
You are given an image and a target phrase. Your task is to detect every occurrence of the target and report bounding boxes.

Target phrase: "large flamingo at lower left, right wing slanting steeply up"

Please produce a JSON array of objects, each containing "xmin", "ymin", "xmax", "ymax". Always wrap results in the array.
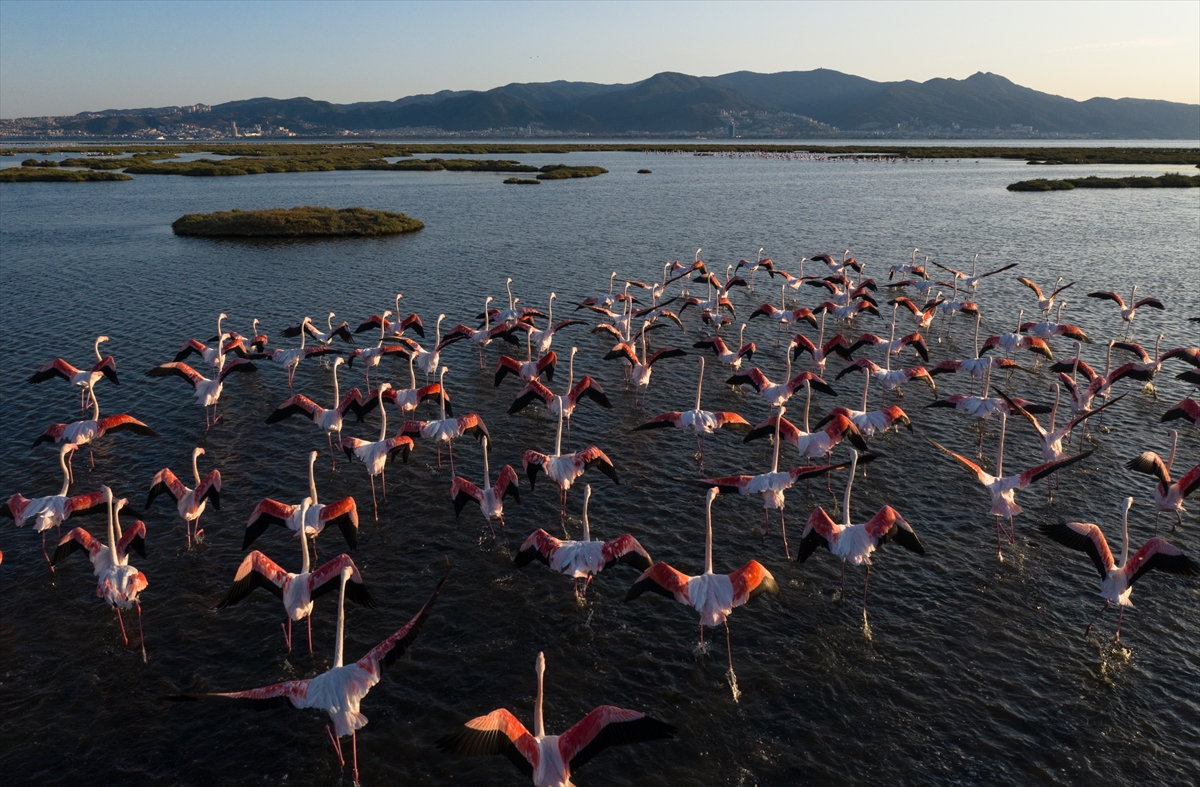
[{"xmin": 190, "ymin": 566, "xmax": 449, "ymax": 785}]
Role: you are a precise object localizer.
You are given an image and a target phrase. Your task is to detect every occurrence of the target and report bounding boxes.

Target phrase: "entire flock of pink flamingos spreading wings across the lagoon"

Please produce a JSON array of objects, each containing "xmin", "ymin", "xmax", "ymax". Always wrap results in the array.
[{"xmin": 0, "ymin": 250, "xmax": 1200, "ymax": 786}]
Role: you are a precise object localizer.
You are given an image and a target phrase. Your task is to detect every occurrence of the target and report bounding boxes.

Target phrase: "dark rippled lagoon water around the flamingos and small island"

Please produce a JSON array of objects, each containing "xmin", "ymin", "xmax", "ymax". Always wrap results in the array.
[{"xmin": 0, "ymin": 154, "xmax": 1200, "ymax": 786}]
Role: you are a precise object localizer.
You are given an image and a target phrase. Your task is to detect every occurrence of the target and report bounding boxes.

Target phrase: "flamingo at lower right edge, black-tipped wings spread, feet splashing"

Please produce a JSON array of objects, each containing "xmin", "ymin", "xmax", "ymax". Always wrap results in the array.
[{"xmin": 1040, "ymin": 498, "xmax": 1200, "ymax": 642}]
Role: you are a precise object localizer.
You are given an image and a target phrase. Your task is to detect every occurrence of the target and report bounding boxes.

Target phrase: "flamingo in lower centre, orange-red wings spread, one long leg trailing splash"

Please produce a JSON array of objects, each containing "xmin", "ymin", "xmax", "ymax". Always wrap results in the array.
[{"xmin": 625, "ymin": 488, "xmax": 779, "ymax": 699}]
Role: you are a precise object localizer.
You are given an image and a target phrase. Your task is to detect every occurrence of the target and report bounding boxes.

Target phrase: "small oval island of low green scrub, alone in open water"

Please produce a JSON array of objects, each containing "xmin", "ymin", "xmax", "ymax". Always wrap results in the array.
[{"xmin": 170, "ymin": 205, "xmax": 425, "ymax": 238}]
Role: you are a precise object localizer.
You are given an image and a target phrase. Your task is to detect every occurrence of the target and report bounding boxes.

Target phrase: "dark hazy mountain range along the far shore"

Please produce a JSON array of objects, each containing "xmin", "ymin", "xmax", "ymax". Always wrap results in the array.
[{"xmin": 21, "ymin": 68, "xmax": 1200, "ymax": 139}]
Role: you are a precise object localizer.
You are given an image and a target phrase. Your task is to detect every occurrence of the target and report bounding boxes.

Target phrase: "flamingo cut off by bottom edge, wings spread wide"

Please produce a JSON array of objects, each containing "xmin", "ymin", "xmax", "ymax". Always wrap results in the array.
[{"xmin": 438, "ymin": 653, "xmax": 676, "ymax": 787}]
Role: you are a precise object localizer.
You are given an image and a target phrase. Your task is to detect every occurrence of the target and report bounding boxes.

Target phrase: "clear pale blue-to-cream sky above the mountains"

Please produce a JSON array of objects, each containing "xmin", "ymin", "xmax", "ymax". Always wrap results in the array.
[{"xmin": 0, "ymin": 0, "xmax": 1200, "ymax": 118}]
